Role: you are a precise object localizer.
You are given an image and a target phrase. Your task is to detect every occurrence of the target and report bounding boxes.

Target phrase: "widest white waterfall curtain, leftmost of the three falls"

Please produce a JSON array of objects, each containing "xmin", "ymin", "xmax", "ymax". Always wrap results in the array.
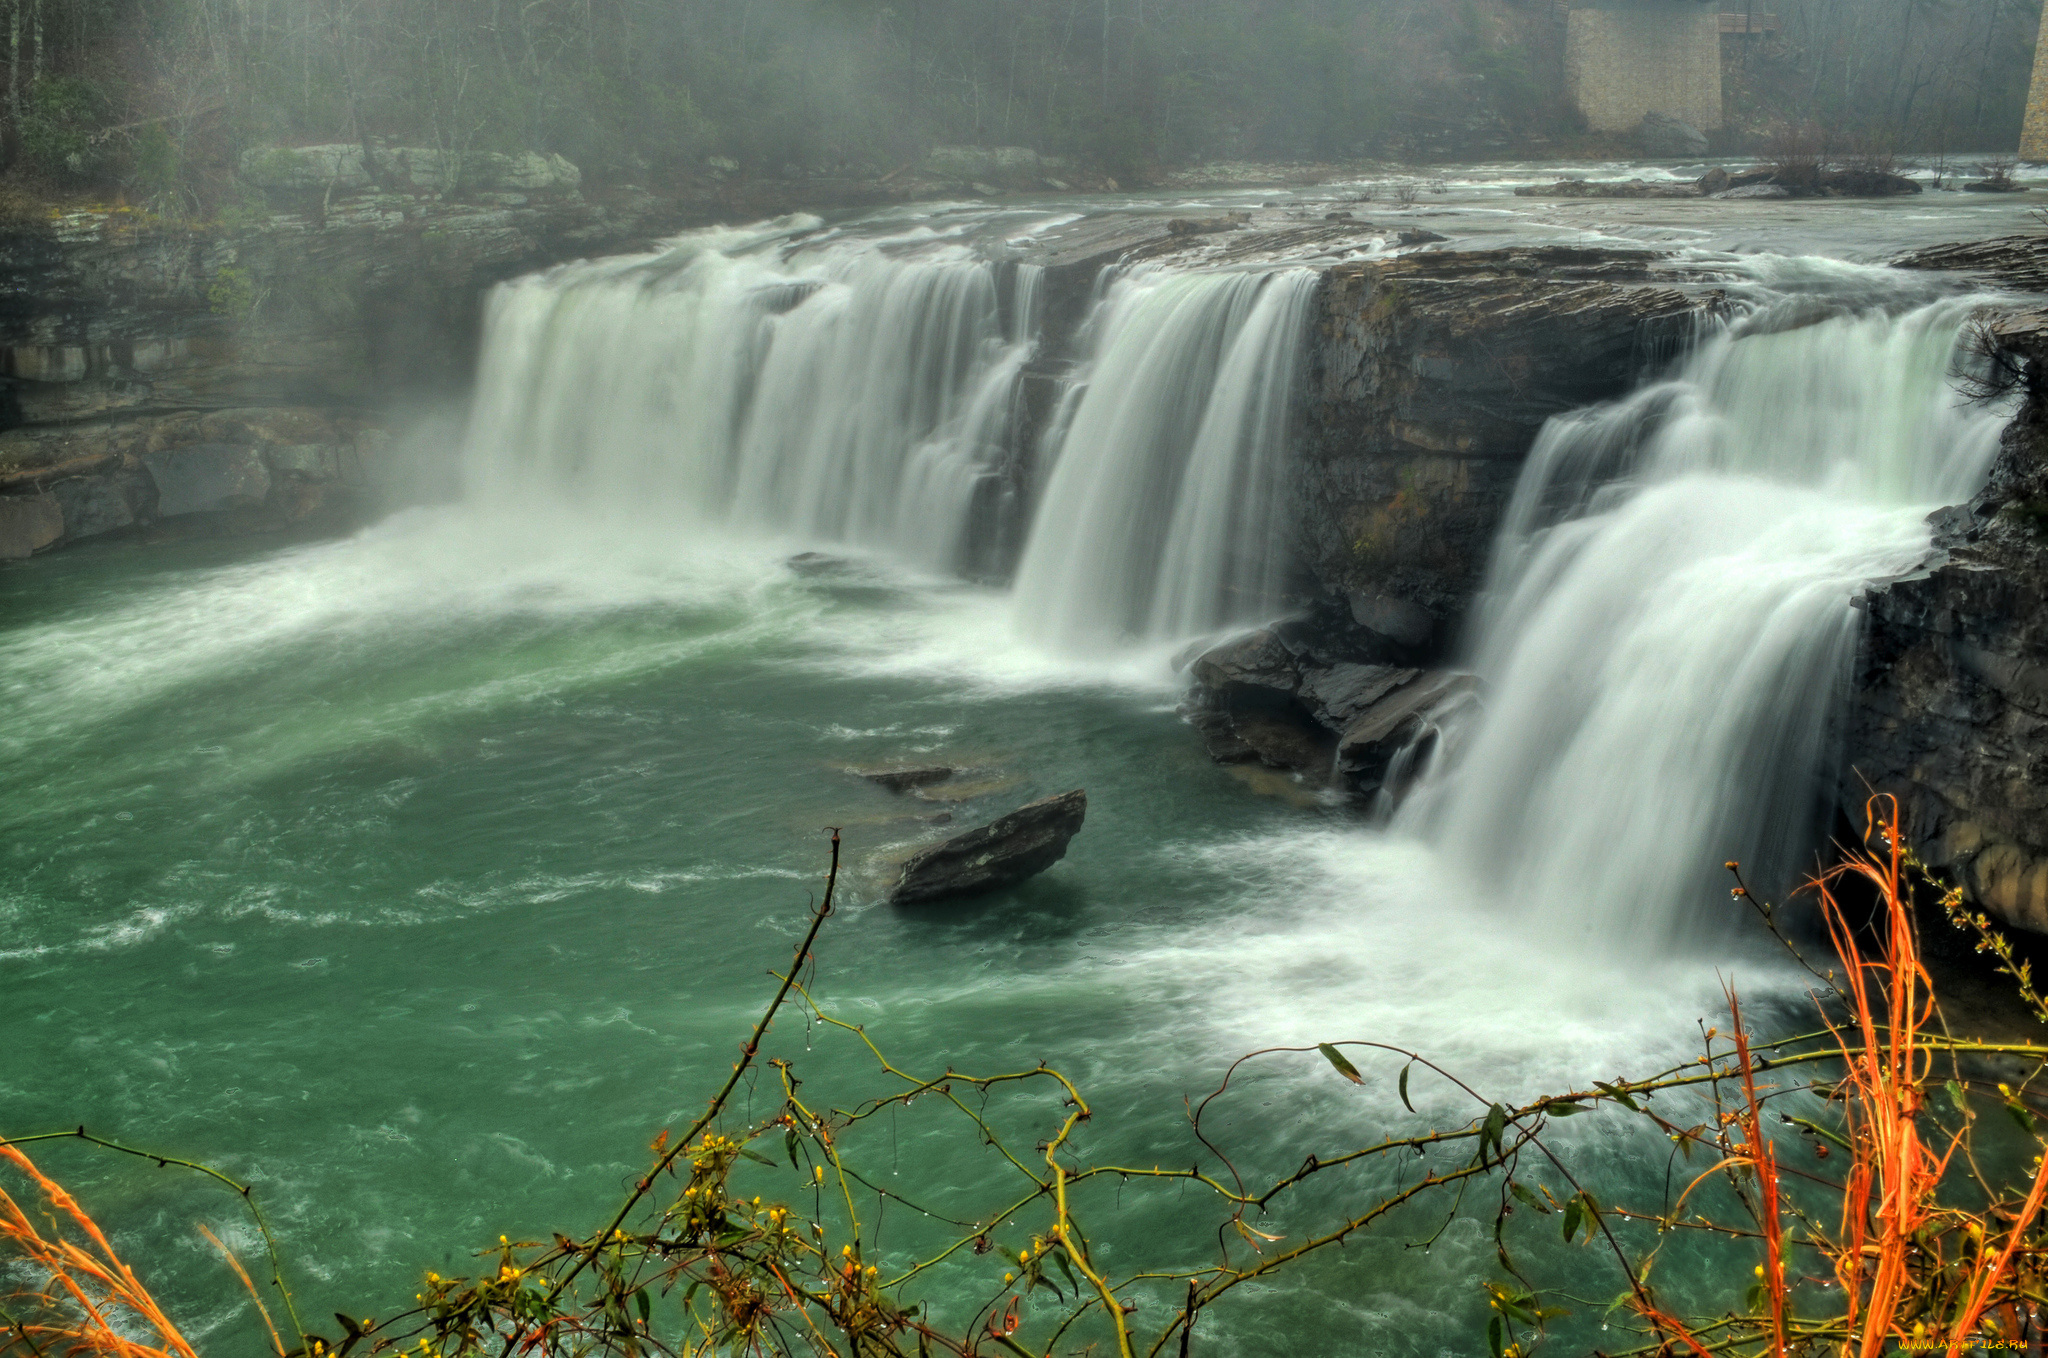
[{"xmin": 463, "ymin": 220, "xmax": 1042, "ymax": 569}]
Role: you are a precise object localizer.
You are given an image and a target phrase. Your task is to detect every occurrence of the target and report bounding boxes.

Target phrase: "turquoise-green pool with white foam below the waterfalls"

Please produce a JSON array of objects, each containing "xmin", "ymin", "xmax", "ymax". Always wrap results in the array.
[{"xmin": 0, "ymin": 508, "xmax": 1780, "ymax": 1354}]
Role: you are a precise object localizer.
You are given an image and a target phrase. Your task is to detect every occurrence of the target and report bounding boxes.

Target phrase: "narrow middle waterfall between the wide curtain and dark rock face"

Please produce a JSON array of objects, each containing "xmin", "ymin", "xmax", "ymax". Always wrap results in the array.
[{"xmin": 1016, "ymin": 268, "xmax": 1317, "ymax": 651}]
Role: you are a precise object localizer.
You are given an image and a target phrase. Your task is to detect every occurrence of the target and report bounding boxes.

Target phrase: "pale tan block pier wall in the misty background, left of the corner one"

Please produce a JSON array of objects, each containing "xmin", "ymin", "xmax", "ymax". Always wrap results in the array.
[{"xmin": 1565, "ymin": 0, "xmax": 1720, "ymax": 131}]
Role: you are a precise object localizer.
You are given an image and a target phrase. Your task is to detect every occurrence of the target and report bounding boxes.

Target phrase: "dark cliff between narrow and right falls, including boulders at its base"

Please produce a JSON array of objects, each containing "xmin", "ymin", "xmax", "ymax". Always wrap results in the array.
[{"xmin": 1190, "ymin": 248, "xmax": 1718, "ymax": 795}]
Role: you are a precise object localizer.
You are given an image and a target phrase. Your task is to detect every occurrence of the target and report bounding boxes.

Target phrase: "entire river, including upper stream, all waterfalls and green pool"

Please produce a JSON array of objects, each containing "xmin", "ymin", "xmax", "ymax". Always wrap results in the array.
[{"xmin": 0, "ymin": 161, "xmax": 2023, "ymax": 1354}]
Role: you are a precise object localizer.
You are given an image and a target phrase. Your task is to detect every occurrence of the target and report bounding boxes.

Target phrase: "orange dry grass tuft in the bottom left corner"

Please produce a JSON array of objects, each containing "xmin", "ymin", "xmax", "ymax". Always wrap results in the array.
[{"xmin": 0, "ymin": 1145, "xmax": 199, "ymax": 1358}]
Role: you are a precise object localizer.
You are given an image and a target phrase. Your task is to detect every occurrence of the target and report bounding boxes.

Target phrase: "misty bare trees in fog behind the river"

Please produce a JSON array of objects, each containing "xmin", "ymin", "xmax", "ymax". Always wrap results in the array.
[{"xmin": 0, "ymin": 0, "xmax": 2040, "ymax": 201}]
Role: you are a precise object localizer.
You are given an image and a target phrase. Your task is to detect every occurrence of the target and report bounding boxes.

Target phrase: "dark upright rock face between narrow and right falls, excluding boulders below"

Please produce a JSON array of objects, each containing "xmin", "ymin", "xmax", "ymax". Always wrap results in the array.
[{"xmin": 1294, "ymin": 246, "xmax": 1718, "ymax": 664}]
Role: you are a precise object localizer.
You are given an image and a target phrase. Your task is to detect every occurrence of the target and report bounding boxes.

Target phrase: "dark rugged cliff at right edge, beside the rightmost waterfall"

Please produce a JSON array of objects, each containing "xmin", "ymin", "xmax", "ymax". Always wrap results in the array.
[{"xmin": 1841, "ymin": 313, "xmax": 2048, "ymax": 932}]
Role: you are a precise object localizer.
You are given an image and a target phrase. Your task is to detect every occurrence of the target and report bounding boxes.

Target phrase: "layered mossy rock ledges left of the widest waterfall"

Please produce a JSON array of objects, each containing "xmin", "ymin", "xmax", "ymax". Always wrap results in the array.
[{"xmin": 0, "ymin": 180, "xmax": 905, "ymax": 559}]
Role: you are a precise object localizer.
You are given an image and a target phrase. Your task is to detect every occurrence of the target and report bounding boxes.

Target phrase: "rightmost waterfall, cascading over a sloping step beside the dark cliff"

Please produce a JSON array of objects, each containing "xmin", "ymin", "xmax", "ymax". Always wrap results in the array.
[{"xmin": 1401, "ymin": 299, "xmax": 2009, "ymax": 948}]
